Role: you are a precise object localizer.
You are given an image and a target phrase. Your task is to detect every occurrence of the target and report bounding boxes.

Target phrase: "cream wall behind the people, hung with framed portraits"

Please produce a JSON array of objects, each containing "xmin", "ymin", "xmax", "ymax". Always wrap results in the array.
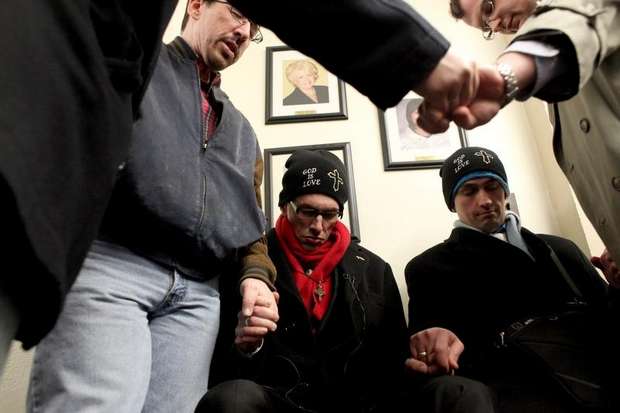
[{"xmin": 0, "ymin": 0, "xmax": 602, "ymax": 413}]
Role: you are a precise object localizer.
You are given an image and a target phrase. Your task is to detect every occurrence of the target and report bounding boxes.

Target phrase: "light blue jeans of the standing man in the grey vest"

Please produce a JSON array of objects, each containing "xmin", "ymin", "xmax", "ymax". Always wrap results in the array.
[{"xmin": 28, "ymin": 241, "xmax": 220, "ymax": 413}]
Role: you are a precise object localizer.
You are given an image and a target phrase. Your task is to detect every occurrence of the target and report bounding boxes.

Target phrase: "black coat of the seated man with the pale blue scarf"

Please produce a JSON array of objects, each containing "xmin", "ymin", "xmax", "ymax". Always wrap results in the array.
[{"xmin": 405, "ymin": 228, "xmax": 608, "ymax": 377}]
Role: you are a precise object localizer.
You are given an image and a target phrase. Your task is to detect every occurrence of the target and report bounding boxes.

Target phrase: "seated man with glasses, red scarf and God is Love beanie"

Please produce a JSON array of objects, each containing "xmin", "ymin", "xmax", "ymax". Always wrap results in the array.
[{"xmin": 196, "ymin": 150, "xmax": 490, "ymax": 413}]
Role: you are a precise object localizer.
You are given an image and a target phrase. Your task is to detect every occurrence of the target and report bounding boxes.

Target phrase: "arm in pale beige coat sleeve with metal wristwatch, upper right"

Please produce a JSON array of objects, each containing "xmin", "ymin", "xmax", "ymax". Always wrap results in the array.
[{"xmin": 440, "ymin": 0, "xmax": 620, "ymax": 129}]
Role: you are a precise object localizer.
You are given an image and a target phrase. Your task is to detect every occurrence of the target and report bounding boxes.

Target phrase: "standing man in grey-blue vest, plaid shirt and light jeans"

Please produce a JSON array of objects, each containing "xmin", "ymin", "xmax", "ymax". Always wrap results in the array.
[{"xmin": 27, "ymin": 0, "xmax": 277, "ymax": 413}]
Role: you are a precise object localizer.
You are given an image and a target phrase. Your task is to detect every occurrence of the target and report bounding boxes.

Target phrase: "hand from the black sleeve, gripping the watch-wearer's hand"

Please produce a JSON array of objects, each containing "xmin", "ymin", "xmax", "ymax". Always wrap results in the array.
[{"xmin": 413, "ymin": 48, "xmax": 478, "ymax": 132}]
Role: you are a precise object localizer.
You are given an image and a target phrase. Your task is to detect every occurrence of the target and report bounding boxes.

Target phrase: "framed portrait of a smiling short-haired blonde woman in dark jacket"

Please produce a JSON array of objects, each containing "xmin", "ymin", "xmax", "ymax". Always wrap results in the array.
[{"xmin": 265, "ymin": 46, "xmax": 348, "ymax": 124}]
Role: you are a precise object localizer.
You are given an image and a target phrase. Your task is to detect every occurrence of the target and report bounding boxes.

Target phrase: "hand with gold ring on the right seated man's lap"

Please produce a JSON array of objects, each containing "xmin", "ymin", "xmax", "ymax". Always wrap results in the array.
[{"xmin": 405, "ymin": 327, "xmax": 465, "ymax": 375}]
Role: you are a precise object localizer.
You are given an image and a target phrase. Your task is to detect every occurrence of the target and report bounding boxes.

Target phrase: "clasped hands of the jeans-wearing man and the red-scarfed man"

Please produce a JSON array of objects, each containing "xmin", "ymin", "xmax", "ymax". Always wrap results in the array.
[{"xmin": 235, "ymin": 278, "xmax": 279, "ymax": 352}]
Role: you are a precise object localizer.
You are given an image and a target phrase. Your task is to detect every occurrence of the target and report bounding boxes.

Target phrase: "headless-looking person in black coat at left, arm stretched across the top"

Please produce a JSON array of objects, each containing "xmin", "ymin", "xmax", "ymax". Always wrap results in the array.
[{"xmin": 0, "ymin": 0, "xmax": 476, "ymax": 371}]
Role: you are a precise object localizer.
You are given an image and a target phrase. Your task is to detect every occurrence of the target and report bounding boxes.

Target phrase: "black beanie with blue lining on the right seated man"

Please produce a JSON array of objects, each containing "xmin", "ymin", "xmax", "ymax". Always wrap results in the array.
[{"xmin": 439, "ymin": 146, "xmax": 510, "ymax": 211}]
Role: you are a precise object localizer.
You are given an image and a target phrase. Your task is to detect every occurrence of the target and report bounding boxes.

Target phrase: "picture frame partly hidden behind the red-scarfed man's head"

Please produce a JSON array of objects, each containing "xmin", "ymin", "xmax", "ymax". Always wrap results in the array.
[{"xmin": 263, "ymin": 142, "xmax": 361, "ymax": 242}]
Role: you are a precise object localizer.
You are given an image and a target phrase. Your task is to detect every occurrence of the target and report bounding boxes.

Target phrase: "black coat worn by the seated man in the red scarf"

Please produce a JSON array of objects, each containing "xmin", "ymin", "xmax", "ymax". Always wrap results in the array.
[{"xmin": 209, "ymin": 230, "xmax": 408, "ymax": 413}]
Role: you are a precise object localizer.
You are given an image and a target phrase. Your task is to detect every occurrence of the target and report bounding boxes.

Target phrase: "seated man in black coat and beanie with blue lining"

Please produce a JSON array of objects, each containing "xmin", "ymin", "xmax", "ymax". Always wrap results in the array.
[{"xmin": 405, "ymin": 147, "xmax": 619, "ymax": 412}]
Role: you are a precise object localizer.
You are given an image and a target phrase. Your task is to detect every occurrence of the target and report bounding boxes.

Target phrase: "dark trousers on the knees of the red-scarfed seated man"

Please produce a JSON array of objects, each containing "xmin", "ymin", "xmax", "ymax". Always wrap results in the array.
[{"xmin": 196, "ymin": 376, "xmax": 494, "ymax": 413}]
